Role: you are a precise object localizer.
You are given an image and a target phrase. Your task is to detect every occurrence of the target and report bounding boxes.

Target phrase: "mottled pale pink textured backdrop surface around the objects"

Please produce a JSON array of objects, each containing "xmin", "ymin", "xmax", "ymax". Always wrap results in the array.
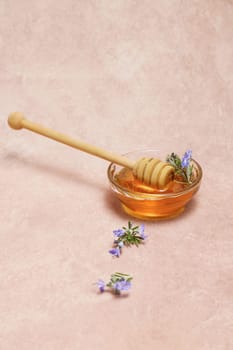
[{"xmin": 0, "ymin": 0, "xmax": 233, "ymax": 350}]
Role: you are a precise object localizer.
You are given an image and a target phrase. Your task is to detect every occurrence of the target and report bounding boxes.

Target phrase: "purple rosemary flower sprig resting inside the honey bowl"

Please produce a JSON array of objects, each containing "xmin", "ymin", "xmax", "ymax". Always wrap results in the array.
[{"xmin": 166, "ymin": 150, "xmax": 193, "ymax": 183}]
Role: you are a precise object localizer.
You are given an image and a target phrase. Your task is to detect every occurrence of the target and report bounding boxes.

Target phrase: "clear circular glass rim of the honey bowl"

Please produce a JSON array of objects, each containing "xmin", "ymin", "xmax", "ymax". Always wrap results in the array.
[{"xmin": 107, "ymin": 149, "xmax": 203, "ymax": 200}]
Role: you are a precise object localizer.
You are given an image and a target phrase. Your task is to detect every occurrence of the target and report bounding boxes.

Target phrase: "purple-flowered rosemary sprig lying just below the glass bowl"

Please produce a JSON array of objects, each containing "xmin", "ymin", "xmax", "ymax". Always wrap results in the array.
[{"xmin": 109, "ymin": 221, "xmax": 147, "ymax": 258}]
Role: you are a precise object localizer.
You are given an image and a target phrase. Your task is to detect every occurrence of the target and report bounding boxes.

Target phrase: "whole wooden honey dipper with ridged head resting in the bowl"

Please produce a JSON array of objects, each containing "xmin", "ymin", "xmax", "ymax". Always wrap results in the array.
[{"xmin": 8, "ymin": 112, "xmax": 174, "ymax": 189}]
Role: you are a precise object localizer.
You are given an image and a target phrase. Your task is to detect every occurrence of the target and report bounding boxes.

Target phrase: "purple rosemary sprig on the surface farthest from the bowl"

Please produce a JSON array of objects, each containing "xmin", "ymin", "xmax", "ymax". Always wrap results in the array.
[{"xmin": 96, "ymin": 272, "xmax": 133, "ymax": 294}]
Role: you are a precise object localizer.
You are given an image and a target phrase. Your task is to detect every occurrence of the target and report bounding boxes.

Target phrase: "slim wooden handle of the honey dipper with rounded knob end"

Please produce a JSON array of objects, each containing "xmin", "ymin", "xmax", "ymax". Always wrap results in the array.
[{"xmin": 8, "ymin": 112, "xmax": 135, "ymax": 169}]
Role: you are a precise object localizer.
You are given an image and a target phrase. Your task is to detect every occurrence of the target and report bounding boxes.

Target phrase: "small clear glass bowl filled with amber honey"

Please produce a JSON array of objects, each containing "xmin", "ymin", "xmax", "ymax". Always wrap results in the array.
[{"xmin": 107, "ymin": 150, "xmax": 202, "ymax": 220}]
